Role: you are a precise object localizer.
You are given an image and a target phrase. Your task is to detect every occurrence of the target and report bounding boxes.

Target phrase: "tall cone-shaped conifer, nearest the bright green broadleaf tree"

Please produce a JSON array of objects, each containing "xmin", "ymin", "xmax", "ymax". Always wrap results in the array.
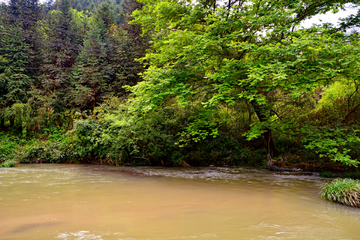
[{"xmin": 72, "ymin": 2, "xmax": 115, "ymax": 108}]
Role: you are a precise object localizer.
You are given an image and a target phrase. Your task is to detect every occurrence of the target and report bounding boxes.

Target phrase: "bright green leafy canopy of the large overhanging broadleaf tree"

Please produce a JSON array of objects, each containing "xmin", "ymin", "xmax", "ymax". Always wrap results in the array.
[{"xmin": 131, "ymin": 0, "xmax": 359, "ymax": 165}]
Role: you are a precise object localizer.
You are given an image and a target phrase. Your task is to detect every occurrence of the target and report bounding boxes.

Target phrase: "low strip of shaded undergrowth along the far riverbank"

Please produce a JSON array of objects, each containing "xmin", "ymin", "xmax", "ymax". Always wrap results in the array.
[{"xmin": 0, "ymin": 130, "xmax": 358, "ymax": 176}]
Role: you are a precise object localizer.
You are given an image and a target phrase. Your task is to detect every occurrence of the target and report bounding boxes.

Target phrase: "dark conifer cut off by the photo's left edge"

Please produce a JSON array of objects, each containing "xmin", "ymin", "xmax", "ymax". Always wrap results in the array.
[{"xmin": 0, "ymin": 0, "xmax": 40, "ymax": 127}]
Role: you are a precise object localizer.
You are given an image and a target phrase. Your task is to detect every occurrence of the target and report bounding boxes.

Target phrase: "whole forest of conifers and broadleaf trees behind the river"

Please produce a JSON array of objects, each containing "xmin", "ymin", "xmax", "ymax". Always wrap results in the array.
[{"xmin": 0, "ymin": 0, "xmax": 360, "ymax": 172}]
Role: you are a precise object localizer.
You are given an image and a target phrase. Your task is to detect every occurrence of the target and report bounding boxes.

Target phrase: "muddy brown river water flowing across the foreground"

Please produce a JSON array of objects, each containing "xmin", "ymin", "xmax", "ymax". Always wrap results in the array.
[{"xmin": 0, "ymin": 164, "xmax": 360, "ymax": 240}]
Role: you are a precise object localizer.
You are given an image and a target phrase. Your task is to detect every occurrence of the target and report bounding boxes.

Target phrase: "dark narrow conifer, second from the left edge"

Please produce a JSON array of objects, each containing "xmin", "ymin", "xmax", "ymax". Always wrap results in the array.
[{"xmin": 40, "ymin": 0, "xmax": 78, "ymax": 112}]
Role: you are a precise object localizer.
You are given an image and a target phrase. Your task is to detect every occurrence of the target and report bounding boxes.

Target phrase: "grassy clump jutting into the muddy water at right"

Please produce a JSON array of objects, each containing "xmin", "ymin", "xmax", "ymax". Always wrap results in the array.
[{"xmin": 320, "ymin": 178, "xmax": 360, "ymax": 207}]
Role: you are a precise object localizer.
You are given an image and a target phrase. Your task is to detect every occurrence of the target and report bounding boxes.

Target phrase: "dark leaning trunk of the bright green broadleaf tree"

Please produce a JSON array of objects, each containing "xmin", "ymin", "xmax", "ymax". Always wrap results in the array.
[{"xmin": 251, "ymin": 100, "xmax": 278, "ymax": 159}]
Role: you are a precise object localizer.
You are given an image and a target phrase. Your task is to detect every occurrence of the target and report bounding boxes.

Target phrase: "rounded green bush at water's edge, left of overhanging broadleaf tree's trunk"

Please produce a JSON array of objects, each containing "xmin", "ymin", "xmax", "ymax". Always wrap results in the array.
[{"xmin": 104, "ymin": 106, "xmax": 185, "ymax": 165}]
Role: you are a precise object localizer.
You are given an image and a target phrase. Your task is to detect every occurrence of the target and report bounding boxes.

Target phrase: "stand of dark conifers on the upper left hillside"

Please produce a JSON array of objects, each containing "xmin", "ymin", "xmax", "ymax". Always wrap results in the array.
[{"xmin": 0, "ymin": 0, "xmax": 144, "ymax": 131}]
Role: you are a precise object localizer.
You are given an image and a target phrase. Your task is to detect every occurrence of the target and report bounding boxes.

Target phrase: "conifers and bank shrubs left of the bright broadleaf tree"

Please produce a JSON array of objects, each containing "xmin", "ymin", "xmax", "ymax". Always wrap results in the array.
[{"xmin": 0, "ymin": 0, "xmax": 146, "ymax": 165}]
